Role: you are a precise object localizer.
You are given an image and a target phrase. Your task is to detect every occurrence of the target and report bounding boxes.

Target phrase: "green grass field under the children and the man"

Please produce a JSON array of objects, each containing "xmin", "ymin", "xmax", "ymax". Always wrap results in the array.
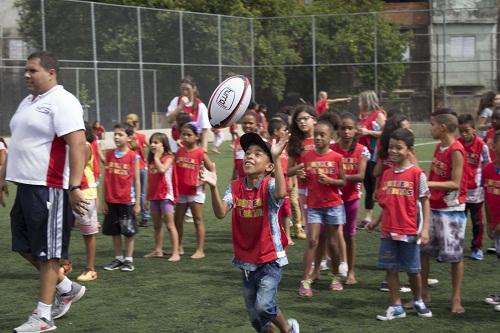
[{"xmin": 0, "ymin": 139, "xmax": 500, "ymax": 333}]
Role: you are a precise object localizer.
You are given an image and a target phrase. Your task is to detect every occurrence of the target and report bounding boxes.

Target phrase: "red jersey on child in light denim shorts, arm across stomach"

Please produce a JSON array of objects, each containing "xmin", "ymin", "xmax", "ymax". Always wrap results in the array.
[{"xmin": 302, "ymin": 149, "xmax": 343, "ymax": 208}]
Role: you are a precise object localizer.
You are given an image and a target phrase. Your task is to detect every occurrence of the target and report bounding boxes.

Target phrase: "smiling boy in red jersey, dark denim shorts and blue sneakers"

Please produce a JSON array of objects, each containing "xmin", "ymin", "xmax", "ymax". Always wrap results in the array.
[{"xmin": 367, "ymin": 128, "xmax": 432, "ymax": 321}]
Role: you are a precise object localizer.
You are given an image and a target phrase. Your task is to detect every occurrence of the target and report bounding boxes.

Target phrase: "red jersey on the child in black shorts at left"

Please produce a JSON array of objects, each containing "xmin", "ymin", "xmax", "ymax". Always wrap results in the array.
[{"xmin": 104, "ymin": 149, "xmax": 138, "ymax": 205}]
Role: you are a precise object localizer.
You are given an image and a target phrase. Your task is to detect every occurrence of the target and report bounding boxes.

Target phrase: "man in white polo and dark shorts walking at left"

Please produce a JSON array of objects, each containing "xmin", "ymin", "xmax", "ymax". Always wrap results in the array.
[{"xmin": 0, "ymin": 51, "xmax": 87, "ymax": 333}]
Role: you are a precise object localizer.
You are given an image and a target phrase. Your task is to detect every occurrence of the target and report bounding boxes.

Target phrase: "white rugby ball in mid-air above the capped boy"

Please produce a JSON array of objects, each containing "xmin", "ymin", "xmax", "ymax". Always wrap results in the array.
[{"xmin": 208, "ymin": 75, "xmax": 252, "ymax": 128}]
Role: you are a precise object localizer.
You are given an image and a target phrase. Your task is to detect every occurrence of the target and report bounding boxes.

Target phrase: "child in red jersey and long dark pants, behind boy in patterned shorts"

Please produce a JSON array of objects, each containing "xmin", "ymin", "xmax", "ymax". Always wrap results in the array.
[{"xmin": 458, "ymin": 114, "xmax": 490, "ymax": 260}]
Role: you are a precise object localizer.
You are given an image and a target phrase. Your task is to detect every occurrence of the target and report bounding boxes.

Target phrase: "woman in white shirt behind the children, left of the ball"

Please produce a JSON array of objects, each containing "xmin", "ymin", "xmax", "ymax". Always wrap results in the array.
[{"xmin": 166, "ymin": 77, "xmax": 212, "ymax": 151}]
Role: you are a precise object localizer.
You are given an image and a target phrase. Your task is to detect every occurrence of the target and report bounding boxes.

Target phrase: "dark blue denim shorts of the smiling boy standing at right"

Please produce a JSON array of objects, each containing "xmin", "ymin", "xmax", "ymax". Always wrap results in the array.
[{"xmin": 377, "ymin": 237, "xmax": 420, "ymax": 273}]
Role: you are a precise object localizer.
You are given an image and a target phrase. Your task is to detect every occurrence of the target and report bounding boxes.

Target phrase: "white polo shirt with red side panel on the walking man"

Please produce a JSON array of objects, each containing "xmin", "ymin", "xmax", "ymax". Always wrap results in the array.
[{"xmin": 6, "ymin": 85, "xmax": 85, "ymax": 188}]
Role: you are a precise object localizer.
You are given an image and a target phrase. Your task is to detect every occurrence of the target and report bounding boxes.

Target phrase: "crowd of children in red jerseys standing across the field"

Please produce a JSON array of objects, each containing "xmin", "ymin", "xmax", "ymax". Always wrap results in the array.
[{"xmin": 4, "ymin": 82, "xmax": 500, "ymax": 333}]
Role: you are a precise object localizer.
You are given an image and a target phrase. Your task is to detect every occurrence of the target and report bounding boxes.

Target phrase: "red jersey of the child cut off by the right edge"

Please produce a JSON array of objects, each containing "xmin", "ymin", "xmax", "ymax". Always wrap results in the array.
[{"xmin": 482, "ymin": 162, "xmax": 500, "ymax": 228}]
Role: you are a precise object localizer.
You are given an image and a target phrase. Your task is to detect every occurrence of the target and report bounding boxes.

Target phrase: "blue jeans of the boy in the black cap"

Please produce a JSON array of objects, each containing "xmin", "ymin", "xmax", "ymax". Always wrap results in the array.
[{"xmin": 242, "ymin": 262, "xmax": 282, "ymax": 332}]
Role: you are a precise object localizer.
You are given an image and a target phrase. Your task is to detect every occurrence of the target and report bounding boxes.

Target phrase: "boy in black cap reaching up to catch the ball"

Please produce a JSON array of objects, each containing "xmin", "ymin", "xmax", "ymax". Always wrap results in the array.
[{"xmin": 201, "ymin": 133, "xmax": 299, "ymax": 333}]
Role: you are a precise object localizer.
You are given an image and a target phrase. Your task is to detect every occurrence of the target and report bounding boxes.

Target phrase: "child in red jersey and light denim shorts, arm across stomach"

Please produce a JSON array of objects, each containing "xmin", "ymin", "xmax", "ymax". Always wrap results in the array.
[{"xmin": 299, "ymin": 120, "xmax": 348, "ymax": 297}]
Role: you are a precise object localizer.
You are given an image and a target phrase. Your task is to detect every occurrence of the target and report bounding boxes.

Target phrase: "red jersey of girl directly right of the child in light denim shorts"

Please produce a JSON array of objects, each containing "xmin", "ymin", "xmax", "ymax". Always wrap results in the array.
[{"xmin": 330, "ymin": 143, "xmax": 365, "ymax": 202}]
